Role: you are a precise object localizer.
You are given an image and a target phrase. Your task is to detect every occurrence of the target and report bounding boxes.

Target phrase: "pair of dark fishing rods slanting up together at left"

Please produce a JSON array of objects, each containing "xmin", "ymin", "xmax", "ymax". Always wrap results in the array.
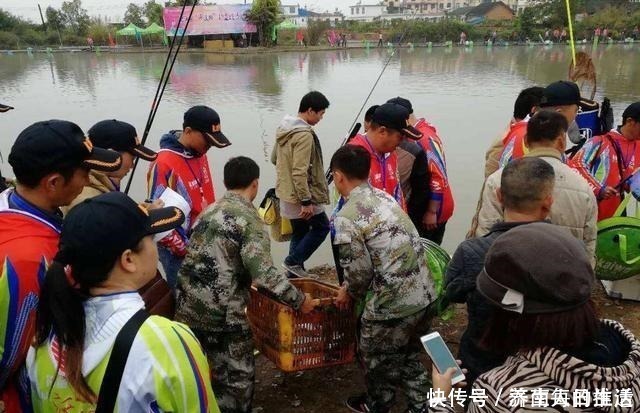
[{"xmin": 124, "ymin": 0, "xmax": 198, "ymax": 195}]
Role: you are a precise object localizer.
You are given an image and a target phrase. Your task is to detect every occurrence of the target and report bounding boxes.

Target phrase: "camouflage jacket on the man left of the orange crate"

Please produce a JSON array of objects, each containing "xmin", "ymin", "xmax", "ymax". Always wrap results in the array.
[{"xmin": 176, "ymin": 192, "xmax": 304, "ymax": 331}]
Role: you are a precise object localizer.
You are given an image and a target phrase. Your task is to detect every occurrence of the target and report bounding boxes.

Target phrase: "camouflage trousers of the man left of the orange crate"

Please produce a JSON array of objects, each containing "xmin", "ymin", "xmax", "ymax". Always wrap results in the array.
[{"xmin": 193, "ymin": 329, "xmax": 256, "ymax": 413}]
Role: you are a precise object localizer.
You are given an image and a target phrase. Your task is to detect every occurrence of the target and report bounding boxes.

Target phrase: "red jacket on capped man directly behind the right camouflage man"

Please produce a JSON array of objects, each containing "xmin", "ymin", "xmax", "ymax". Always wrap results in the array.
[{"xmin": 349, "ymin": 134, "xmax": 406, "ymax": 211}]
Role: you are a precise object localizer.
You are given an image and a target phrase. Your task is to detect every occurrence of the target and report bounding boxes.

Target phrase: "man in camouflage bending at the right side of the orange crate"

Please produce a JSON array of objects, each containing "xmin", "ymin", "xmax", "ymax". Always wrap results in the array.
[{"xmin": 331, "ymin": 145, "xmax": 436, "ymax": 413}]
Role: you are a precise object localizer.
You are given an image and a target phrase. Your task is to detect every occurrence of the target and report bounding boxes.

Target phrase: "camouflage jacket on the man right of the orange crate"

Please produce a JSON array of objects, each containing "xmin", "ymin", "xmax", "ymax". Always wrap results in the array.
[{"xmin": 333, "ymin": 184, "xmax": 436, "ymax": 320}]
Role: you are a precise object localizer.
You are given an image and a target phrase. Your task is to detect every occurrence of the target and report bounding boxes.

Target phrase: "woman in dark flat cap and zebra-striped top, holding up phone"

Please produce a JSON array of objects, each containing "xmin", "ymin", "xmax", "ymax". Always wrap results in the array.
[{"xmin": 430, "ymin": 223, "xmax": 640, "ymax": 413}]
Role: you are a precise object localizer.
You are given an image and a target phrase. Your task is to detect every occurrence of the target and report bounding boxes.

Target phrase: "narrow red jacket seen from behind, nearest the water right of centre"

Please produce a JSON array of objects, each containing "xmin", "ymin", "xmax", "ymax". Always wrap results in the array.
[{"xmin": 414, "ymin": 119, "xmax": 455, "ymax": 224}]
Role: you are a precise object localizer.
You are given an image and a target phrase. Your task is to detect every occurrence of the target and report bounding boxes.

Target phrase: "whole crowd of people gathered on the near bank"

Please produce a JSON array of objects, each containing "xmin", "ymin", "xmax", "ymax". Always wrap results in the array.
[{"xmin": 0, "ymin": 81, "xmax": 640, "ymax": 413}]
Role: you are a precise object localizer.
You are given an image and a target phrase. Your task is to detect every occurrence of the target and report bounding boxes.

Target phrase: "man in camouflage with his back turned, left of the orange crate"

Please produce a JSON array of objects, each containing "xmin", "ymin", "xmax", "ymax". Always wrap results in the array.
[{"xmin": 176, "ymin": 157, "xmax": 316, "ymax": 413}]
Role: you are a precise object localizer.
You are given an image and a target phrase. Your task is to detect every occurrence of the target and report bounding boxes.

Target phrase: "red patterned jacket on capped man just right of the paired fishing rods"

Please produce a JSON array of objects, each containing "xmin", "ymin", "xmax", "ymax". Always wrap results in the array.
[{"xmin": 147, "ymin": 132, "xmax": 216, "ymax": 256}]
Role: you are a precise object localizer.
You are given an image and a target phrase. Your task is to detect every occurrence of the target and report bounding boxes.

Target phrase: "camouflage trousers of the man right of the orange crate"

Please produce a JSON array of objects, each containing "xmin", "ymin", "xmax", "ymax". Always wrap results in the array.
[{"xmin": 359, "ymin": 310, "xmax": 430, "ymax": 413}]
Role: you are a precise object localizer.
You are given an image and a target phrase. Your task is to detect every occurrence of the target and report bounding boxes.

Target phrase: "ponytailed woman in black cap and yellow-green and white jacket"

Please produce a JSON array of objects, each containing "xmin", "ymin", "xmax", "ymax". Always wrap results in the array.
[{"xmin": 27, "ymin": 192, "xmax": 219, "ymax": 413}]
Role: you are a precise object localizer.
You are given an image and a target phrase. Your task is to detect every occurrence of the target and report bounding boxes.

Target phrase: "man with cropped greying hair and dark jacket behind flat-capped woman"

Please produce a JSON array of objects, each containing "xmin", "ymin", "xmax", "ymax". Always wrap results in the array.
[{"xmin": 446, "ymin": 158, "xmax": 555, "ymax": 395}]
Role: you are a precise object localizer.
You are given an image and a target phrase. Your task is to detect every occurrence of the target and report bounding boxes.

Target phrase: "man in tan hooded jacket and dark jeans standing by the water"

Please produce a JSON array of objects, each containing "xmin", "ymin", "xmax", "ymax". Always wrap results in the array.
[{"xmin": 271, "ymin": 91, "xmax": 329, "ymax": 277}]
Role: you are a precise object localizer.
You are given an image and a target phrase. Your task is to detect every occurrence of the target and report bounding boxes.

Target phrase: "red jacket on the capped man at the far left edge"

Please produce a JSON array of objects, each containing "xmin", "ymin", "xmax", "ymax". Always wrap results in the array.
[{"xmin": 0, "ymin": 189, "xmax": 60, "ymax": 412}]
